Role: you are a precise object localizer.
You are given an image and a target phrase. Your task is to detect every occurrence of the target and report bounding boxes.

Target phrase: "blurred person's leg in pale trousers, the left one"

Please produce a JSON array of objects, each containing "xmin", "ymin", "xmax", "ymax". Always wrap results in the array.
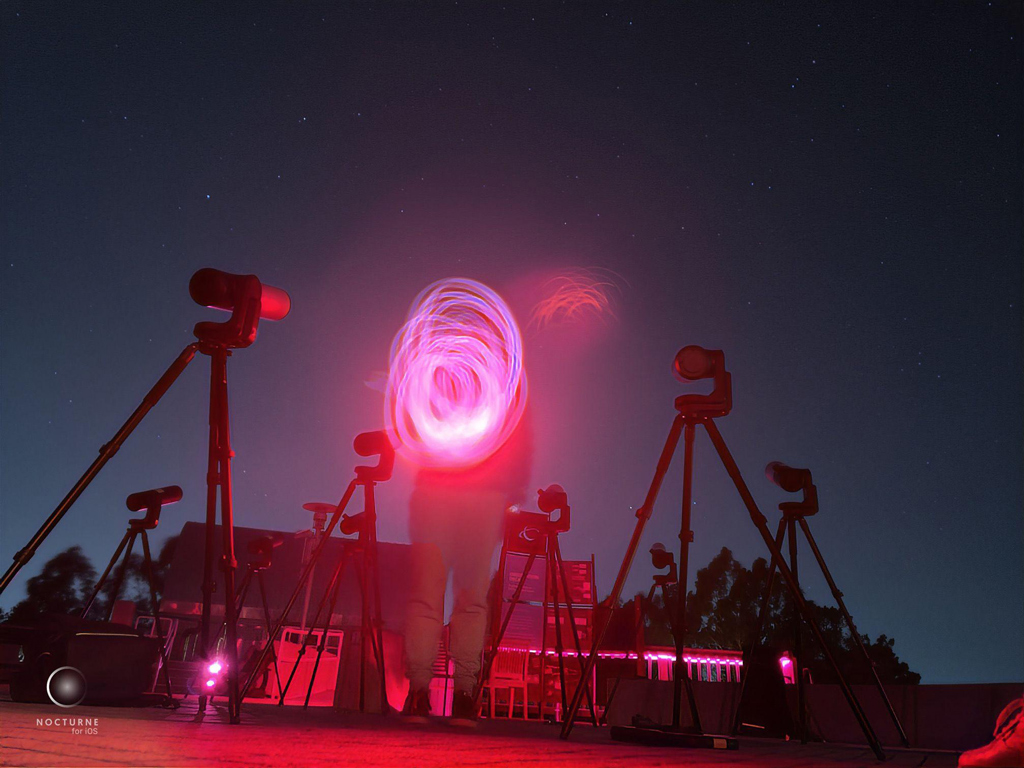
[{"xmin": 406, "ymin": 543, "xmax": 447, "ymax": 690}]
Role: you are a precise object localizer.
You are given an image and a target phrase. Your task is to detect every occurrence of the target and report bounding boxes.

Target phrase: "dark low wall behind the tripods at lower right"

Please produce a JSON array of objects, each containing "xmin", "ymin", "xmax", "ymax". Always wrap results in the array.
[{"xmin": 608, "ymin": 679, "xmax": 1024, "ymax": 751}]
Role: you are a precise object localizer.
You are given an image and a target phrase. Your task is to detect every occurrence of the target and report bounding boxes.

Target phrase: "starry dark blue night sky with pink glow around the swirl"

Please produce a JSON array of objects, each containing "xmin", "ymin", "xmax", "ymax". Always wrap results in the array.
[{"xmin": 0, "ymin": 2, "xmax": 1024, "ymax": 683}]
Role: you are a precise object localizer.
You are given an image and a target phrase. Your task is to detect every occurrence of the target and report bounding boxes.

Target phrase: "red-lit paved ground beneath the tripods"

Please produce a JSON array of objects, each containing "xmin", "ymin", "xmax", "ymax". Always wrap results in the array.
[{"xmin": 0, "ymin": 699, "xmax": 956, "ymax": 768}]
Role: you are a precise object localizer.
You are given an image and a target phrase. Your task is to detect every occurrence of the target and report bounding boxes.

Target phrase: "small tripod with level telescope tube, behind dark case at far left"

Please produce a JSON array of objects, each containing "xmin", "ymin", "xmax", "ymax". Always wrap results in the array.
[{"xmin": 82, "ymin": 485, "xmax": 181, "ymax": 700}]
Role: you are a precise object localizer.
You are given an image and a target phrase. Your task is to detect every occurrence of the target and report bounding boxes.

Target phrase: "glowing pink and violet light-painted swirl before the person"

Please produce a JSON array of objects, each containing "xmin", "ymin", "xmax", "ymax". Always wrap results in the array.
[{"xmin": 384, "ymin": 278, "xmax": 526, "ymax": 469}]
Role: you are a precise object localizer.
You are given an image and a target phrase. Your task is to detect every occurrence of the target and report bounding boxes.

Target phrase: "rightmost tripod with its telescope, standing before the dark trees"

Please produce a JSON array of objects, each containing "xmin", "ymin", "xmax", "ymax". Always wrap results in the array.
[{"xmin": 732, "ymin": 462, "xmax": 910, "ymax": 746}]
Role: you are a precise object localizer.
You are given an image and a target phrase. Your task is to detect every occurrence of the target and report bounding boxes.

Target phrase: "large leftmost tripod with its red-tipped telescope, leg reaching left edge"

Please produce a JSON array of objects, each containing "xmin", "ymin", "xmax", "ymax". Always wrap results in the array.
[{"xmin": 0, "ymin": 268, "xmax": 291, "ymax": 723}]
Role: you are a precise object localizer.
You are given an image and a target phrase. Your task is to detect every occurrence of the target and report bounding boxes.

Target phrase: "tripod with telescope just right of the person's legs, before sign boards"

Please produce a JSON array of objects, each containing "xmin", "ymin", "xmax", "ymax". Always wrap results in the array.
[{"xmin": 476, "ymin": 485, "xmax": 597, "ymax": 725}]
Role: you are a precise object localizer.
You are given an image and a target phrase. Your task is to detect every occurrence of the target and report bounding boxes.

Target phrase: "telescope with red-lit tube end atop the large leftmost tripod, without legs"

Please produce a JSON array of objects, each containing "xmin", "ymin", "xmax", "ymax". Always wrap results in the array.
[{"xmin": 188, "ymin": 267, "xmax": 292, "ymax": 348}]
